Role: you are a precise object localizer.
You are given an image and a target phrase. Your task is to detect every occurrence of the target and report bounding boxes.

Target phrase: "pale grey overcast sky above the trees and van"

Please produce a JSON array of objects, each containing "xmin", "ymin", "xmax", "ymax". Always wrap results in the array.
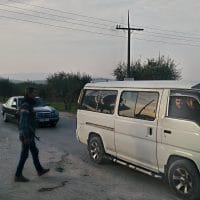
[{"xmin": 0, "ymin": 0, "xmax": 200, "ymax": 81}]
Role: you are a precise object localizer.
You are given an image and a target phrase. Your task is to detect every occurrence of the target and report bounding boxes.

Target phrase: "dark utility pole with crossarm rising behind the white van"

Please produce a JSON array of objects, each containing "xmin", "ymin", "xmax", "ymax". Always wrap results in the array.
[{"xmin": 116, "ymin": 11, "xmax": 144, "ymax": 78}]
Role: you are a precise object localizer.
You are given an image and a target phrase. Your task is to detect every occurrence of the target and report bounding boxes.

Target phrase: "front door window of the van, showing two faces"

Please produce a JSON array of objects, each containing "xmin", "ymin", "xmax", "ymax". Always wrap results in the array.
[{"xmin": 168, "ymin": 90, "xmax": 200, "ymax": 125}]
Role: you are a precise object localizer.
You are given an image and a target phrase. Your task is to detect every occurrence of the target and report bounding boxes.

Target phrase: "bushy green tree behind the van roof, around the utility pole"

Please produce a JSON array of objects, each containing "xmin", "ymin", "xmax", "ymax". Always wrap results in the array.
[{"xmin": 113, "ymin": 56, "xmax": 181, "ymax": 80}]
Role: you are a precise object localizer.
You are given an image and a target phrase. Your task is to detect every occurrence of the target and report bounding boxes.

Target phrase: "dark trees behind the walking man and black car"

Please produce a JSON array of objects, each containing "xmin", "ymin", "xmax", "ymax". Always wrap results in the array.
[{"xmin": 0, "ymin": 72, "xmax": 92, "ymax": 110}]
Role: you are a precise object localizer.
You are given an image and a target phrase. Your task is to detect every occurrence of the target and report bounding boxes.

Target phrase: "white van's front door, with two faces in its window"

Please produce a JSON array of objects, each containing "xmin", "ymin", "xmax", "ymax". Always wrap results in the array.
[{"xmin": 158, "ymin": 90, "xmax": 200, "ymax": 159}]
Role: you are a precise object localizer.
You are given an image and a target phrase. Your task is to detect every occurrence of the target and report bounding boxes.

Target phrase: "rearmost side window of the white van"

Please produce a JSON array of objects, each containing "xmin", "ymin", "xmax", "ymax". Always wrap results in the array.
[{"xmin": 79, "ymin": 90, "xmax": 117, "ymax": 114}]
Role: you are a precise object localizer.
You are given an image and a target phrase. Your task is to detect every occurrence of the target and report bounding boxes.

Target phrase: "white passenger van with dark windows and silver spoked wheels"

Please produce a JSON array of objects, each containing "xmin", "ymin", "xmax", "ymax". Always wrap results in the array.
[{"xmin": 76, "ymin": 81, "xmax": 200, "ymax": 199}]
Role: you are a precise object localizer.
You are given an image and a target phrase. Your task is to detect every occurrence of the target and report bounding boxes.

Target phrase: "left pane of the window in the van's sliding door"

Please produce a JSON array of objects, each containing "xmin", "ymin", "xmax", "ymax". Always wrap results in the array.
[{"xmin": 118, "ymin": 91, "xmax": 138, "ymax": 118}]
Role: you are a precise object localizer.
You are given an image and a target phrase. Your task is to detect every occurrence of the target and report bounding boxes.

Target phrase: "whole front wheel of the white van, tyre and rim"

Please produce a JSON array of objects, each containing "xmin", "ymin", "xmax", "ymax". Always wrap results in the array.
[{"xmin": 168, "ymin": 159, "xmax": 200, "ymax": 200}]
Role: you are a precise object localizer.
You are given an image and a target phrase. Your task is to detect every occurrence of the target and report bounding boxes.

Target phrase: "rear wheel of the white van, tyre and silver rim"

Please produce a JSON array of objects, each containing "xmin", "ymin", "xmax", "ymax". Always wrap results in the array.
[{"xmin": 88, "ymin": 136, "xmax": 105, "ymax": 164}]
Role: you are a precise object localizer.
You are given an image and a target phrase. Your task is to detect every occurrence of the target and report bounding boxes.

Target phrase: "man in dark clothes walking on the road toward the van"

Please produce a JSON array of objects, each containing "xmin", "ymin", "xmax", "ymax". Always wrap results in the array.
[{"xmin": 14, "ymin": 87, "xmax": 49, "ymax": 182}]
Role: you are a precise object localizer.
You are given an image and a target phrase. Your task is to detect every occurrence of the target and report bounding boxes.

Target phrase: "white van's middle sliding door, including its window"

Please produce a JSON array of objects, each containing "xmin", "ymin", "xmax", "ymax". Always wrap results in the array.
[{"xmin": 115, "ymin": 90, "xmax": 162, "ymax": 171}]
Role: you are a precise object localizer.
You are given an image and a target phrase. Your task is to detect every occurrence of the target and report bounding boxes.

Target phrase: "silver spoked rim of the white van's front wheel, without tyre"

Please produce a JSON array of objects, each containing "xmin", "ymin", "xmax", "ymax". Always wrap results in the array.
[{"xmin": 173, "ymin": 168, "xmax": 192, "ymax": 195}]
